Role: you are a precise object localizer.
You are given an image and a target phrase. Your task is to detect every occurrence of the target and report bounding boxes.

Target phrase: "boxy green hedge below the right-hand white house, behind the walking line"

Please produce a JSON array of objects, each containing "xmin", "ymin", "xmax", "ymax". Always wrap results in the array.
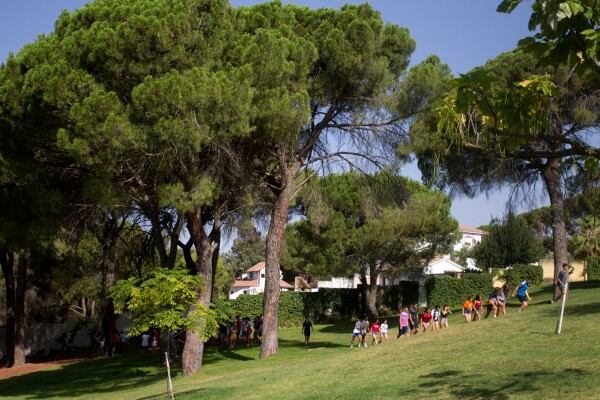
[{"xmin": 426, "ymin": 273, "xmax": 492, "ymax": 307}]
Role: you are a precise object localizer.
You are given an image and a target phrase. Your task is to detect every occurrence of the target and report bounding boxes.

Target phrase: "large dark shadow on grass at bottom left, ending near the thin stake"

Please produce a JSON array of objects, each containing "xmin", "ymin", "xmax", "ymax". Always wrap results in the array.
[{"xmin": 0, "ymin": 354, "xmax": 166, "ymax": 399}]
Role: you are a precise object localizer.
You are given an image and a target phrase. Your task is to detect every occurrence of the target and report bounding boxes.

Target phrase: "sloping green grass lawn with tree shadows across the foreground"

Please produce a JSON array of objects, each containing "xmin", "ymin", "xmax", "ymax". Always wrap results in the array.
[{"xmin": 0, "ymin": 283, "xmax": 600, "ymax": 400}]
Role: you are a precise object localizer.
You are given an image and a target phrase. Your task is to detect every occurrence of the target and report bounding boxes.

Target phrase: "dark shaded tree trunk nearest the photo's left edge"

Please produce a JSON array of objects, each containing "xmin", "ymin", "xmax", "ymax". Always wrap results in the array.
[{"xmin": 0, "ymin": 249, "xmax": 16, "ymax": 367}]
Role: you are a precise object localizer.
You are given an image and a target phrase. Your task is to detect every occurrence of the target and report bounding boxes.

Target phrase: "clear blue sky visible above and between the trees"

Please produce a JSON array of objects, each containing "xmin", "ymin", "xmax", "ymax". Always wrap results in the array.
[{"xmin": 0, "ymin": 0, "xmax": 545, "ymax": 226}]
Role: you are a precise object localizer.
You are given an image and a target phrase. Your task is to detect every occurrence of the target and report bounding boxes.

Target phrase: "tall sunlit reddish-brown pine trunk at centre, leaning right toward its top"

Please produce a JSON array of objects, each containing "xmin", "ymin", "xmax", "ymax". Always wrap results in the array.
[{"xmin": 260, "ymin": 162, "xmax": 300, "ymax": 358}]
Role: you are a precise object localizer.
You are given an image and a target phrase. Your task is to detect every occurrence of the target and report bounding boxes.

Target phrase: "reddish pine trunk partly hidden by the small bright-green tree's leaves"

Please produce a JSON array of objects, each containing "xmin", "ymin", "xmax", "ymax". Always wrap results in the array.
[{"xmin": 181, "ymin": 207, "xmax": 216, "ymax": 375}]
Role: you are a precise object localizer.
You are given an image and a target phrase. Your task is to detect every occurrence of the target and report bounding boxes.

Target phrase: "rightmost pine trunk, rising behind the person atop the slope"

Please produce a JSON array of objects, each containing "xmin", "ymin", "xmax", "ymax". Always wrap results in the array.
[{"xmin": 542, "ymin": 158, "xmax": 568, "ymax": 286}]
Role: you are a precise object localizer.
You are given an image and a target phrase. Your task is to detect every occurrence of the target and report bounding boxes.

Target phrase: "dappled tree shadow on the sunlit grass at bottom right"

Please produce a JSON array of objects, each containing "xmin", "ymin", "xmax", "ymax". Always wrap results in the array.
[{"xmin": 418, "ymin": 368, "xmax": 589, "ymax": 400}]
